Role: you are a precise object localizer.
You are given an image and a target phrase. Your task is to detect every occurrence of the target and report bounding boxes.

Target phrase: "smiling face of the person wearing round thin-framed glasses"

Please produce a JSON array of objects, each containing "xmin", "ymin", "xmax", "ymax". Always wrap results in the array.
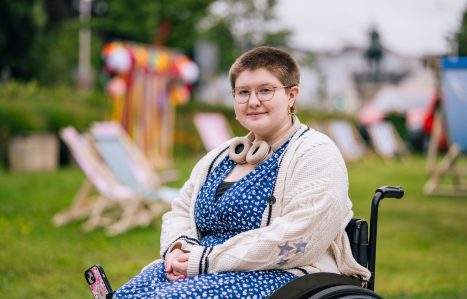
[{"xmin": 234, "ymin": 69, "xmax": 298, "ymax": 139}]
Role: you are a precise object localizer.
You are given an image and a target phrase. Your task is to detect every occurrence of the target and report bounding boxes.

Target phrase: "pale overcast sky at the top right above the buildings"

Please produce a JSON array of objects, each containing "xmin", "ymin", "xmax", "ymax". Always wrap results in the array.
[{"xmin": 276, "ymin": 0, "xmax": 467, "ymax": 57}]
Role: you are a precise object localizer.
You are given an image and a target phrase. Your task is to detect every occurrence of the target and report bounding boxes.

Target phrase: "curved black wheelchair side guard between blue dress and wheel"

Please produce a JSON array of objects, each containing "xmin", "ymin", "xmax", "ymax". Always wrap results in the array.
[{"xmin": 269, "ymin": 272, "xmax": 362, "ymax": 299}]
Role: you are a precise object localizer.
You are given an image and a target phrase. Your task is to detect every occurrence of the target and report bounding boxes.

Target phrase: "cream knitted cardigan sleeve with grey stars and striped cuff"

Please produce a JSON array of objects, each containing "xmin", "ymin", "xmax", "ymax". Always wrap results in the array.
[{"xmin": 188, "ymin": 142, "xmax": 358, "ymax": 276}]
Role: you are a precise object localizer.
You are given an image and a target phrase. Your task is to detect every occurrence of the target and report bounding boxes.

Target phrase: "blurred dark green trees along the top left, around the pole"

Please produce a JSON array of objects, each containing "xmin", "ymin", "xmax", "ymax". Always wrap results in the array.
[{"xmin": 0, "ymin": 0, "xmax": 290, "ymax": 85}]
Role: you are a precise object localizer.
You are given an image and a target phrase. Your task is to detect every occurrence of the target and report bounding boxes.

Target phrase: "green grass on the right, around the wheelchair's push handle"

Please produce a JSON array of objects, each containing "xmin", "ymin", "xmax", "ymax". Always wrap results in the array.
[{"xmin": 348, "ymin": 157, "xmax": 467, "ymax": 298}]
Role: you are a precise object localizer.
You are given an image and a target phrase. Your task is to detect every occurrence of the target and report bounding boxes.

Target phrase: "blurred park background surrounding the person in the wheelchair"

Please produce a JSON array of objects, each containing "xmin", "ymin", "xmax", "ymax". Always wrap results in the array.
[{"xmin": 0, "ymin": 0, "xmax": 467, "ymax": 298}]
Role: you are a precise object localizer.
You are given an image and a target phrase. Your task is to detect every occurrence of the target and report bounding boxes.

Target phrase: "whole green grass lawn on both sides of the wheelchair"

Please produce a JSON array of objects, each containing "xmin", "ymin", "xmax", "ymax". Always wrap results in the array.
[{"xmin": 0, "ymin": 156, "xmax": 467, "ymax": 299}]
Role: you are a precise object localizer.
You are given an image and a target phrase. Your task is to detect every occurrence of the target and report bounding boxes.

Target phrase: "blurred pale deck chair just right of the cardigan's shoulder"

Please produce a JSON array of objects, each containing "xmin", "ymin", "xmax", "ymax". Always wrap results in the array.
[{"xmin": 326, "ymin": 120, "xmax": 365, "ymax": 162}]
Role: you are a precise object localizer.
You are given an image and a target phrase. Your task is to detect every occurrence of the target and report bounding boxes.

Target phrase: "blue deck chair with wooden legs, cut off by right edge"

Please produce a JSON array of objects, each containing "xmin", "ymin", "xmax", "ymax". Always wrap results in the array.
[{"xmin": 423, "ymin": 57, "xmax": 467, "ymax": 196}]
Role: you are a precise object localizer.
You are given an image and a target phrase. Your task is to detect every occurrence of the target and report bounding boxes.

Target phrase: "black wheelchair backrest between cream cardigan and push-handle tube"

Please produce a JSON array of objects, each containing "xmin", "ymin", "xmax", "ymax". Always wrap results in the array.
[{"xmin": 345, "ymin": 219, "xmax": 369, "ymax": 268}]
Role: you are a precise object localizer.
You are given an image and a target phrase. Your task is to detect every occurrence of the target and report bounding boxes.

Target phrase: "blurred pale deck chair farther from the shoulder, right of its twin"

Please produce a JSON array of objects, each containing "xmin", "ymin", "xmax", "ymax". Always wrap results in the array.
[{"xmin": 367, "ymin": 121, "xmax": 409, "ymax": 161}]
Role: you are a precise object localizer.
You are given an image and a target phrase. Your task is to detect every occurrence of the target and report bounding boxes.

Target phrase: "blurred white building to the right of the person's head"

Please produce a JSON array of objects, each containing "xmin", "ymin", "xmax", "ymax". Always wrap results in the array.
[{"xmin": 308, "ymin": 47, "xmax": 434, "ymax": 114}]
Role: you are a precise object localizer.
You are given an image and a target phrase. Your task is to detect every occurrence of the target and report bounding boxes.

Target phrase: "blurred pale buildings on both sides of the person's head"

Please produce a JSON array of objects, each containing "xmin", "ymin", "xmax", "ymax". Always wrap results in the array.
[{"xmin": 195, "ymin": 34, "xmax": 434, "ymax": 115}]
